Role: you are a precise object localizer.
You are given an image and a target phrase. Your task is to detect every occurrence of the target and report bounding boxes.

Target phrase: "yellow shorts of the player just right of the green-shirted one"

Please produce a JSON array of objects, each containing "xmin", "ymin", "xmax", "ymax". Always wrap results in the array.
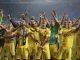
[{"xmin": 58, "ymin": 47, "xmax": 72, "ymax": 60}]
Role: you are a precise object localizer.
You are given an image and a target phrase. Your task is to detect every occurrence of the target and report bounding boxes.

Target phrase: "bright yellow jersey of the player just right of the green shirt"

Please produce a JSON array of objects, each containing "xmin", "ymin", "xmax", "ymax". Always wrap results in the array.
[{"xmin": 60, "ymin": 28, "xmax": 75, "ymax": 47}]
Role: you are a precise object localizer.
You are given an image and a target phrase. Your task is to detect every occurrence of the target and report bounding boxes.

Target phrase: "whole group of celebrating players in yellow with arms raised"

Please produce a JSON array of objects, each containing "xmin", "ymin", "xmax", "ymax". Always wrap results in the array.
[{"xmin": 0, "ymin": 10, "xmax": 80, "ymax": 60}]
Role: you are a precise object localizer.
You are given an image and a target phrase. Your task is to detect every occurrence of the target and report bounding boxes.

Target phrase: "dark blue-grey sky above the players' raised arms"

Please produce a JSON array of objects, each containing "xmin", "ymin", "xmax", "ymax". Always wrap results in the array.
[{"xmin": 0, "ymin": 0, "xmax": 80, "ymax": 20}]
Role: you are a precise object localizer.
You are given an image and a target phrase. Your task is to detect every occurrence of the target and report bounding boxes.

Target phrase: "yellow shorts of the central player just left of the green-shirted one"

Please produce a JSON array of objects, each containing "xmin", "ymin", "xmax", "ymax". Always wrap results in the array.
[{"xmin": 35, "ymin": 43, "xmax": 50, "ymax": 59}]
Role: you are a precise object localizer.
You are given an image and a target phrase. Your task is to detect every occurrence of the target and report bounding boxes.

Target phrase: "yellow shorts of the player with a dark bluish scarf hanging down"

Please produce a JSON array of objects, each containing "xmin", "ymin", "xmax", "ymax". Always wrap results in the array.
[{"xmin": 16, "ymin": 46, "xmax": 28, "ymax": 59}]
